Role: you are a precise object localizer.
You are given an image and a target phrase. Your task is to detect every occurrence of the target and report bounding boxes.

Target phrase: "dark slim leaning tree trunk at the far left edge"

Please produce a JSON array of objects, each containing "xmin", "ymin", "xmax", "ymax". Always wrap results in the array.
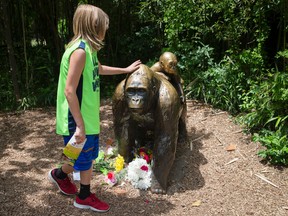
[{"xmin": 0, "ymin": 0, "xmax": 21, "ymax": 101}]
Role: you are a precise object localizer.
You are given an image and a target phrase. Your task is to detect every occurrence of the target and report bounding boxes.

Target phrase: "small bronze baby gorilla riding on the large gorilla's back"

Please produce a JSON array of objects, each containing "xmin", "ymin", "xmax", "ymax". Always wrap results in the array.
[{"xmin": 150, "ymin": 52, "xmax": 186, "ymax": 103}]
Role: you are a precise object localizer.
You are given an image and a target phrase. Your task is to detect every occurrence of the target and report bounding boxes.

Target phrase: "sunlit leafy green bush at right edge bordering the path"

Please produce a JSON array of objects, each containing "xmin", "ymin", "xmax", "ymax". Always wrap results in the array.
[{"xmin": 238, "ymin": 53, "xmax": 288, "ymax": 165}]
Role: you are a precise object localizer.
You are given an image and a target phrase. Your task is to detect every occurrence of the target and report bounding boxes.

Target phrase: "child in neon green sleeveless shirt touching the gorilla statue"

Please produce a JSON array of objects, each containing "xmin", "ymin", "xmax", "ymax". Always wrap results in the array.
[{"xmin": 48, "ymin": 4, "xmax": 141, "ymax": 212}]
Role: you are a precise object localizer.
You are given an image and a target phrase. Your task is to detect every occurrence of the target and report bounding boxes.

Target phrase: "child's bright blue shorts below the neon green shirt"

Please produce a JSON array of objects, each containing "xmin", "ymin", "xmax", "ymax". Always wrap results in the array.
[{"xmin": 63, "ymin": 135, "xmax": 99, "ymax": 171}]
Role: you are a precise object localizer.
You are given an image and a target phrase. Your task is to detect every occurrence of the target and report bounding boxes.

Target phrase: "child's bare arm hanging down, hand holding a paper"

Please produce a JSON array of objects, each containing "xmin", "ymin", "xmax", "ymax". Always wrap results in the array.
[{"xmin": 65, "ymin": 49, "xmax": 86, "ymax": 143}]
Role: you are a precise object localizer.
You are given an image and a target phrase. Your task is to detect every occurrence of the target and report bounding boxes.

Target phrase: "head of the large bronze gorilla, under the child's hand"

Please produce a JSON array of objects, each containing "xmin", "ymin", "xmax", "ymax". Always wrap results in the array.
[{"xmin": 125, "ymin": 67, "xmax": 155, "ymax": 113}]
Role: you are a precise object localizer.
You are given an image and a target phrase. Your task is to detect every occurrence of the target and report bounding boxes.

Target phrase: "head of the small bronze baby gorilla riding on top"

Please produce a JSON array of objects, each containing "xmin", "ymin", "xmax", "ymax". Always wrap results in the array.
[{"xmin": 159, "ymin": 52, "xmax": 178, "ymax": 75}]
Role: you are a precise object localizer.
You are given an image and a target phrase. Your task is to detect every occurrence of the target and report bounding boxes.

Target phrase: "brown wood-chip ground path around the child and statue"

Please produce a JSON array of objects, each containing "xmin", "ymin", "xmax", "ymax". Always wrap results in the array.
[{"xmin": 0, "ymin": 101, "xmax": 288, "ymax": 216}]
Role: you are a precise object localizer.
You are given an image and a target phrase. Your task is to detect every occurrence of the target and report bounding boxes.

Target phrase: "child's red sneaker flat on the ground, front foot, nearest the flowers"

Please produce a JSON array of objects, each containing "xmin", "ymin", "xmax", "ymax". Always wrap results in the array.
[{"xmin": 74, "ymin": 193, "xmax": 110, "ymax": 212}]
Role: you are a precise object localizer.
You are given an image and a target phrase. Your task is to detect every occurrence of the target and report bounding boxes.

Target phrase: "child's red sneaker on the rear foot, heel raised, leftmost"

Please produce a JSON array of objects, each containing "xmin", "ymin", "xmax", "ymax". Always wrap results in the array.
[{"xmin": 48, "ymin": 169, "xmax": 77, "ymax": 195}]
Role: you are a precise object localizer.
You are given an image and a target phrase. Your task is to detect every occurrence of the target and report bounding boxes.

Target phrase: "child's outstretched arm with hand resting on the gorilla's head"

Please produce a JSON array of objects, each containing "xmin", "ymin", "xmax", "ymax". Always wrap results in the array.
[{"xmin": 99, "ymin": 60, "xmax": 141, "ymax": 75}]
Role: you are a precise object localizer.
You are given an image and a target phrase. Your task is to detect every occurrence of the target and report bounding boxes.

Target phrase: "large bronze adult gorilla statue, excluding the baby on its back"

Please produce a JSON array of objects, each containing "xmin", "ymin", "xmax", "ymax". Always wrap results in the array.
[{"xmin": 112, "ymin": 64, "xmax": 186, "ymax": 194}]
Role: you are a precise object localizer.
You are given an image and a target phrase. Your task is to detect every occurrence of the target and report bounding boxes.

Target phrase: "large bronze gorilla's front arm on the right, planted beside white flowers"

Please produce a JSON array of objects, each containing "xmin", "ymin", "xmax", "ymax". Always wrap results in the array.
[{"xmin": 151, "ymin": 79, "xmax": 183, "ymax": 193}]
